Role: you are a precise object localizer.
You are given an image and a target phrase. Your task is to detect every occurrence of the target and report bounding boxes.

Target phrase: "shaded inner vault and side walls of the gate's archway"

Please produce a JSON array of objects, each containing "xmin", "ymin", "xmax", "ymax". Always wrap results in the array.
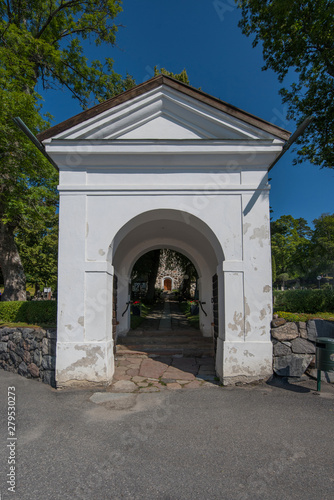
[{"xmin": 108, "ymin": 209, "xmax": 224, "ymax": 348}]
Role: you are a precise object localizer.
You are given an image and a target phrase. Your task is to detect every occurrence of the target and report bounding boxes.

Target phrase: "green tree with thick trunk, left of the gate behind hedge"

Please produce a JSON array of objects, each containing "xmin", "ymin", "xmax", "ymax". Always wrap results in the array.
[{"xmin": 0, "ymin": 78, "xmax": 58, "ymax": 300}]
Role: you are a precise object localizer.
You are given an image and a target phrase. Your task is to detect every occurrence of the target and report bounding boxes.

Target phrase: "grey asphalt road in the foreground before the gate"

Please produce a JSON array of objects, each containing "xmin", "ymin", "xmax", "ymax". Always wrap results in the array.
[{"xmin": 0, "ymin": 371, "xmax": 334, "ymax": 500}]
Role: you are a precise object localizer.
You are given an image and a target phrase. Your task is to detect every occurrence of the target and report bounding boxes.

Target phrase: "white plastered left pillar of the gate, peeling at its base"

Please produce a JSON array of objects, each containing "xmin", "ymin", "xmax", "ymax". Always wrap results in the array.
[{"xmin": 56, "ymin": 194, "xmax": 113, "ymax": 386}]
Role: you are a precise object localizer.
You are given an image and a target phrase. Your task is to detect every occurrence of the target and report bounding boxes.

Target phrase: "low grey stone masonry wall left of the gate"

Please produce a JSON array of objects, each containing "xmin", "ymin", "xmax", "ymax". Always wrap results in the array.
[{"xmin": 0, "ymin": 327, "xmax": 57, "ymax": 387}]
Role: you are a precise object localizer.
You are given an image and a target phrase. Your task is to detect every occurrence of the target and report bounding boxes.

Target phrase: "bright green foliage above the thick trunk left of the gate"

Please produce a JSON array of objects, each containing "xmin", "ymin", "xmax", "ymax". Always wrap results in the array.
[{"xmin": 0, "ymin": 78, "xmax": 58, "ymax": 227}]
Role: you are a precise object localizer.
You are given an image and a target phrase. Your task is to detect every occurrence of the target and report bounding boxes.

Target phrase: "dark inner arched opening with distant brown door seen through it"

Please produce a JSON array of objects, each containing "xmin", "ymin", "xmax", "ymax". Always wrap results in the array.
[{"xmin": 116, "ymin": 248, "xmax": 215, "ymax": 363}]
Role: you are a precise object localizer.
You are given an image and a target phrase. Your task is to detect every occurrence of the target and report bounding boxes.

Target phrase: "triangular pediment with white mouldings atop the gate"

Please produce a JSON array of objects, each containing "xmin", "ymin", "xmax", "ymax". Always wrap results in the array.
[{"xmin": 40, "ymin": 77, "xmax": 289, "ymax": 140}]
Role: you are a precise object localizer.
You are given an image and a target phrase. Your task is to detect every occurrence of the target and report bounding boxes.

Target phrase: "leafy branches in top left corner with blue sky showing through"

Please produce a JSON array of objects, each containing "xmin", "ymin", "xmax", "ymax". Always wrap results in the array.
[{"xmin": 0, "ymin": 0, "xmax": 133, "ymax": 107}]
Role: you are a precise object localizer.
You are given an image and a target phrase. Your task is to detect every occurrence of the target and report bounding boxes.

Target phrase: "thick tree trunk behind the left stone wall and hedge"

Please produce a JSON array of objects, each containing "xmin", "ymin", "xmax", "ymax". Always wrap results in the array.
[{"xmin": 0, "ymin": 222, "xmax": 27, "ymax": 301}]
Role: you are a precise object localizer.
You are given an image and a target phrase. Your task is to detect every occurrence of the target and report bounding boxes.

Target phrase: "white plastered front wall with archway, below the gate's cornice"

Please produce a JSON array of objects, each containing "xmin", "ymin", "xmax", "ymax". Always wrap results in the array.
[{"xmin": 57, "ymin": 178, "xmax": 271, "ymax": 385}]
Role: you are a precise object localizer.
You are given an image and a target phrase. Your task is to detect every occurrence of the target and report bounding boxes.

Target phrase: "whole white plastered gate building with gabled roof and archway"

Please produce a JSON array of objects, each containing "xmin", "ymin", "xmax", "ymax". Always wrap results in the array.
[{"xmin": 39, "ymin": 75, "xmax": 290, "ymax": 386}]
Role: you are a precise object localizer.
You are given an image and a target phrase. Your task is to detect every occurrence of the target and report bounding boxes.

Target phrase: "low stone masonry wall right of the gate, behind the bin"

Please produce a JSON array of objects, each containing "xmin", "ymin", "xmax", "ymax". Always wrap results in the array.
[{"xmin": 271, "ymin": 318, "xmax": 334, "ymax": 382}]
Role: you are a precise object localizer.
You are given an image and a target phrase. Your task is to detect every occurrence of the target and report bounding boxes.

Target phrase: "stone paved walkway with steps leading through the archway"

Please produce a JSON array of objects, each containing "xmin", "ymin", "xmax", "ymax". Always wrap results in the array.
[{"xmin": 109, "ymin": 300, "xmax": 219, "ymax": 393}]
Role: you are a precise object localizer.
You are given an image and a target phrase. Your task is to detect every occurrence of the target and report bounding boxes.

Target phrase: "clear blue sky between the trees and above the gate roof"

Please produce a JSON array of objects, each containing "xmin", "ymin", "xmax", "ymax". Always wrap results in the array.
[{"xmin": 38, "ymin": 0, "xmax": 334, "ymax": 224}]
